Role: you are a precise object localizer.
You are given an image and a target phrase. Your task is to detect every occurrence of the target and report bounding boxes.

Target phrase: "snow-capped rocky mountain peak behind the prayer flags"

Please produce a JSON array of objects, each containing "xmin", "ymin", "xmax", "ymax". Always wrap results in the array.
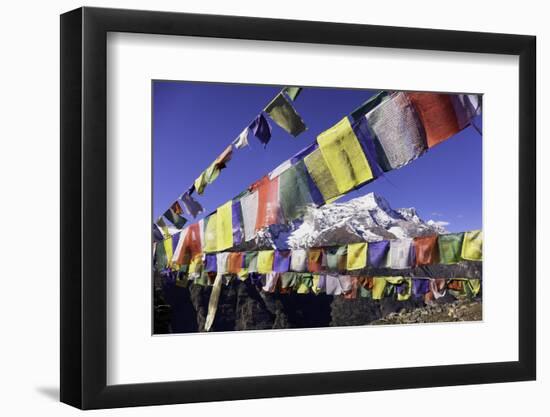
[{"xmin": 256, "ymin": 193, "xmax": 447, "ymax": 249}]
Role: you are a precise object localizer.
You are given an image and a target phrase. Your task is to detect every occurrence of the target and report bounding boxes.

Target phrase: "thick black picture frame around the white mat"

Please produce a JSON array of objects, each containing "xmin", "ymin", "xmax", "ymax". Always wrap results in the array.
[{"xmin": 60, "ymin": 7, "xmax": 536, "ymax": 409}]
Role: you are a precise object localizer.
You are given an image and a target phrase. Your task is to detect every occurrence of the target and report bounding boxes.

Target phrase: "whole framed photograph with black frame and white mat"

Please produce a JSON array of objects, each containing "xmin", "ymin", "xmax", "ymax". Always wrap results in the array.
[{"xmin": 61, "ymin": 7, "xmax": 536, "ymax": 409}]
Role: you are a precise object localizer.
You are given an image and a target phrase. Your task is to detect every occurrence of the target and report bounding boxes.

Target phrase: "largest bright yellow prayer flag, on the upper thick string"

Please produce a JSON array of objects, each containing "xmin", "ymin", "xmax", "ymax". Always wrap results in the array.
[{"xmin": 317, "ymin": 117, "xmax": 373, "ymax": 194}]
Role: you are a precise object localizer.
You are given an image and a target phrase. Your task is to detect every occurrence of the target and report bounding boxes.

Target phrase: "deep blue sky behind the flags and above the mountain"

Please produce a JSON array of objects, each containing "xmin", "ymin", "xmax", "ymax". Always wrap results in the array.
[{"xmin": 153, "ymin": 81, "xmax": 482, "ymax": 231}]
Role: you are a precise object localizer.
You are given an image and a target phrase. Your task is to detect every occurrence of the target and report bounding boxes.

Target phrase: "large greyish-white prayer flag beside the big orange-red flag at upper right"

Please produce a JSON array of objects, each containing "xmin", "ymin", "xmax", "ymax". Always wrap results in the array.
[{"xmin": 365, "ymin": 93, "xmax": 427, "ymax": 171}]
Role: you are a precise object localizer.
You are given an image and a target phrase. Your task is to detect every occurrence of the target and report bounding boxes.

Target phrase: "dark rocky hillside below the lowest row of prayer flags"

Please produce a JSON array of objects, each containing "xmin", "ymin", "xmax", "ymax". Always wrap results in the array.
[{"xmin": 154, "ymin": 280, "xmax": 481, "ymax": 334}]
